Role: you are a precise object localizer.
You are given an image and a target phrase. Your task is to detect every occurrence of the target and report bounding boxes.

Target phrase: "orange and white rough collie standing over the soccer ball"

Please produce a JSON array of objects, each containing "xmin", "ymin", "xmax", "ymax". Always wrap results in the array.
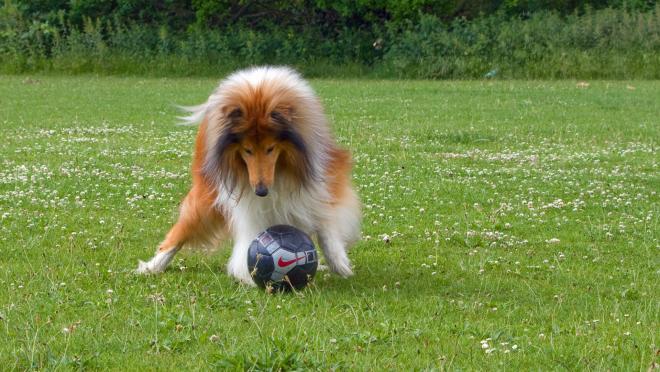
[{"xmin": 137, "ymin": 67, "xmax": 360, "ymax": 285}]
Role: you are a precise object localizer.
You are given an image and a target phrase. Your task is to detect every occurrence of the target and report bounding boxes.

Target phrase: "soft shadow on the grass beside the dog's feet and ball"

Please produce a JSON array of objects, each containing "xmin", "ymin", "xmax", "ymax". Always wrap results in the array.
[{"xmin": 136, "ymin": 243, "xmax": 482, "ymax": 298}]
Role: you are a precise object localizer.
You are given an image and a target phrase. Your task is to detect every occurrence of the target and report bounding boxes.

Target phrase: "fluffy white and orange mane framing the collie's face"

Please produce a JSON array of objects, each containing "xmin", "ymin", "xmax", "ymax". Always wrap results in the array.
[{"xmin": 180, "ymin": 67, "xmax": 334, "ymax": 195}]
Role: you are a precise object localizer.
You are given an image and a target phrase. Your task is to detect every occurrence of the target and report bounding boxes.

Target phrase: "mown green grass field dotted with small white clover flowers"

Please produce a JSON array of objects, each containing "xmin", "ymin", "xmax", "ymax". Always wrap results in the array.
[{"xmin": 0, "ymin": 76, "xmax": 660, "ymax": 371}]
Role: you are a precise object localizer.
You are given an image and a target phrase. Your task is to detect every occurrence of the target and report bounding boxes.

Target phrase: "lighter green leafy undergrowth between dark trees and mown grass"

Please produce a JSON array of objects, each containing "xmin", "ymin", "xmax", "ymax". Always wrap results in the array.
[{"xmin": 0, "ymin": 2, "xmax": 660, "ymax": 79}]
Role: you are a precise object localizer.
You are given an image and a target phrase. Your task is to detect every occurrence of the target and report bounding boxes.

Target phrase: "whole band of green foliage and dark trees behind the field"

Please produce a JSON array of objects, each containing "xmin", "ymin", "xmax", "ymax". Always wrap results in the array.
[{"xmin": 0, "ymin": 0, "xmax": 660, "ymax": 79}]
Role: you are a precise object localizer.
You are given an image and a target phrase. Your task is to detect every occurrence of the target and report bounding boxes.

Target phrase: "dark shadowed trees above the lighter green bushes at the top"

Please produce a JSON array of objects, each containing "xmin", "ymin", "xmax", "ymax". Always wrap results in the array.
[{"xmin": 14, "ymin": 0, "xmax": 656, "ymax": 32}]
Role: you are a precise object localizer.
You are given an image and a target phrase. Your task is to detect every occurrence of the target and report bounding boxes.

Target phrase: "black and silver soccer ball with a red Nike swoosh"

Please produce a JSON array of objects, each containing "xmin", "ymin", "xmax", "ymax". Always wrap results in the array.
[{"xmin": 248, "ymin": 225, "xmax": 318, "ymax": 290}]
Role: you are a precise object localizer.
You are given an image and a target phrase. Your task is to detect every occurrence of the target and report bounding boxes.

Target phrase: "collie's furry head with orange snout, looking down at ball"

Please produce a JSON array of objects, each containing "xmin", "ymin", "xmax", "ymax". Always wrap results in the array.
[{"xmin": 204, "ymin": 68, "xmax": 323, "ymax": 197}]
